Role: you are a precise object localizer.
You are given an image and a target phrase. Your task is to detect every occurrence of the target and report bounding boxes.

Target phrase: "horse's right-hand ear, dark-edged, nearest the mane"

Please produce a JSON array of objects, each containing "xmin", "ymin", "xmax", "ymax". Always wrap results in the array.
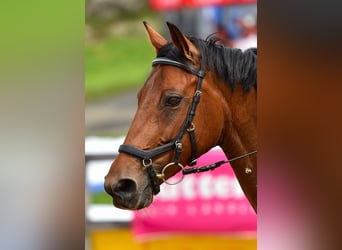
[{"xmin": 167, "ymin": 22, "xmax": 200, "ymax": 65}]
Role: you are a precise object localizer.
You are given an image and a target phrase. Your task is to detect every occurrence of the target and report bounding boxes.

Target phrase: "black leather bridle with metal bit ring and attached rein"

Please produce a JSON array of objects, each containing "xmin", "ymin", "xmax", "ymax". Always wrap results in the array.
[{"xmin": 119, "ymin": 57, "xmax": 257, "ymax": 195}]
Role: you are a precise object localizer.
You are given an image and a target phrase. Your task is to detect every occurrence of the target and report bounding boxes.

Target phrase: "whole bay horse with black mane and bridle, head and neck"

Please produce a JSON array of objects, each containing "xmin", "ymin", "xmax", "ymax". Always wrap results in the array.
[{"xmin": 104, "ymin": 22, "xmax": 257, "ymax": 212}]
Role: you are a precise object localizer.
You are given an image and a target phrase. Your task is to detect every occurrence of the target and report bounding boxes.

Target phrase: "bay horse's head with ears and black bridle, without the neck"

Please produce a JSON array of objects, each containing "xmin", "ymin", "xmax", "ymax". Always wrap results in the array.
[{"xmin": 105, "ymin": 22, "xmax": 229, "ymax": 210}]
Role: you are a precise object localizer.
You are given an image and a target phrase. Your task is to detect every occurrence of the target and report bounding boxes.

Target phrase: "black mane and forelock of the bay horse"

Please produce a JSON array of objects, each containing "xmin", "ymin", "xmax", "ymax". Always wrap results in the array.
[{"xmin": 157, "ymin": 37, "xmax": 257, "ymax": 91}]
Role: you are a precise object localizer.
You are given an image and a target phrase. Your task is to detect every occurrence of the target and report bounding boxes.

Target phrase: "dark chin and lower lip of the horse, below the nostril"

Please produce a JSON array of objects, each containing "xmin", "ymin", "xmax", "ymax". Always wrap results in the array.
[{"xmin": 113, "ymin": 186, "xmax": 153, "ymax": 210}]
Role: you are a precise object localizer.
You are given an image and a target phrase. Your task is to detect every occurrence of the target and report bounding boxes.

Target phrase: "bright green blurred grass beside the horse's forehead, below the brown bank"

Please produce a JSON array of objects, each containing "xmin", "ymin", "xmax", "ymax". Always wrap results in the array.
[{"xmin": 85, "ymin": 35, "xmax": 154, "ymax": 101}]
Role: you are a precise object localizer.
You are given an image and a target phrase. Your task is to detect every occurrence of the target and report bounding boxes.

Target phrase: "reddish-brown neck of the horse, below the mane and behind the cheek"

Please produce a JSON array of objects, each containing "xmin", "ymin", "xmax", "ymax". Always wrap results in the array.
[{"xmin": 214, "ymin": 76, "xmax": 257, "ymax": 211}]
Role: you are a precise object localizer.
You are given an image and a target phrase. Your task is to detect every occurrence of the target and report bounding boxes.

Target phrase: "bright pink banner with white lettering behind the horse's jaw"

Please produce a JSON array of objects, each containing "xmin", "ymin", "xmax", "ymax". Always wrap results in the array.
[{"xmin": 133, "ymin": 148, "xmax": 257, "ymax": 237}]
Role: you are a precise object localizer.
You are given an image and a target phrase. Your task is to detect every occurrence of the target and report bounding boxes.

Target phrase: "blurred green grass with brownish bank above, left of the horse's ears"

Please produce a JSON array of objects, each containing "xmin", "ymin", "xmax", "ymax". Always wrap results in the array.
[{"xmin": 85, "ymin": 0, "xmax": 161, "ymax": 103}]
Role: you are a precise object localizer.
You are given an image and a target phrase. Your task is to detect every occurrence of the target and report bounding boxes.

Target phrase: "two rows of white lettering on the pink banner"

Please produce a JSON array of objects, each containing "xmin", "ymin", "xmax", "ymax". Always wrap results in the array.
[{"xmin": 134, "ymin": 174, "xmax": 252, "ymax": 218}]
